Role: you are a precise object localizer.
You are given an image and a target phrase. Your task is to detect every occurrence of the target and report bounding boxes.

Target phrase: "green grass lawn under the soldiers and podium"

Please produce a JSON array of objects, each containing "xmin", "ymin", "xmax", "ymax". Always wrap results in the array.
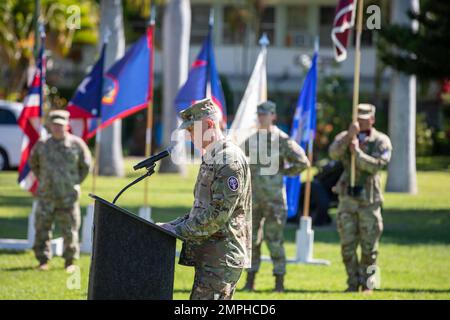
[{"xmin": 0, "ymin": 159, "xmax": 450, "ymax": 299}]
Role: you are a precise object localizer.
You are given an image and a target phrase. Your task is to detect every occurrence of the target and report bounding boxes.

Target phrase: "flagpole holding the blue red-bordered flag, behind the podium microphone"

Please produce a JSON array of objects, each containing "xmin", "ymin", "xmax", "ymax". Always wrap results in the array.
[{"xmin": 144, "ymin": 5, "xmax": 156, "ymax": 208}]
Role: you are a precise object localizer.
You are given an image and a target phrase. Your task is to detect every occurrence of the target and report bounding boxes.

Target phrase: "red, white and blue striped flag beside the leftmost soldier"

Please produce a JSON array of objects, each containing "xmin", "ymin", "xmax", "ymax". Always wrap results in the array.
[{"xmin": 17, "ymin": 26, "xmax": 46, "ymax": 194}]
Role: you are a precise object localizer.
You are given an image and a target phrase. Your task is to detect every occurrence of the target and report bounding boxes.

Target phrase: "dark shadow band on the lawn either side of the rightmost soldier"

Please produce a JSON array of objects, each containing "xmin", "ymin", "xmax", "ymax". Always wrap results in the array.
[{"xmin": 285, "ymin": 209, "xmax": 450, "ymax": 245}]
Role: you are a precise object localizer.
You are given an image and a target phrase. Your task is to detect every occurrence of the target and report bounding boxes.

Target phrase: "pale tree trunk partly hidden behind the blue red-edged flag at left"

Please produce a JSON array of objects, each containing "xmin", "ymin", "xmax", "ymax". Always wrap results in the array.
[{"xmin": 99, "ymin": 0, "xmax": 125, "ymax": 177}]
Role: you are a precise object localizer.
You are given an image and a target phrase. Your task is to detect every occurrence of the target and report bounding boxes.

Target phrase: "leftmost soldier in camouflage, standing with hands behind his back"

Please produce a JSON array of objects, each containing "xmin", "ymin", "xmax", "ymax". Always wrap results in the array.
[{"xmin": 30, "ymin": 110, "xmax": 91, "ymax": 272}]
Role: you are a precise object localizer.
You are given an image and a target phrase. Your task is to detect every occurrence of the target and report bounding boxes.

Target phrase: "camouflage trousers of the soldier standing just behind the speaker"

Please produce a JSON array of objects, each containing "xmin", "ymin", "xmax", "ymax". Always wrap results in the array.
[{"xmin": 248, "ymin": 201, "xmax": 287, "ymax": 275}]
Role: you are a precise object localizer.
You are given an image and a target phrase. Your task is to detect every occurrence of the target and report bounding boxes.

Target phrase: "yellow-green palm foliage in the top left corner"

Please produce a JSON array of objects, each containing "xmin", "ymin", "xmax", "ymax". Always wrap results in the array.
[{"xmin": 0, "ymin": 0, "xmax": 98, "ymax": 100}]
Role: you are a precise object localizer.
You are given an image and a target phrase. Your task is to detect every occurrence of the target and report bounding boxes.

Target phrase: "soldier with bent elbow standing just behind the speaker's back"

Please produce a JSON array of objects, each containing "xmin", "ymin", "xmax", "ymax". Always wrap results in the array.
[{"xmin": 243, "ymin": 101, "xmax": 309, "ymax": 292}]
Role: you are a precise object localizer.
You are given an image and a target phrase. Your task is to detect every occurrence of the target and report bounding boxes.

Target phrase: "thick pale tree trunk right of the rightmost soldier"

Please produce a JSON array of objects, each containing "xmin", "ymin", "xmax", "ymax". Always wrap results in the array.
[{"xmin": 386, "ymin": 0, "xmax": 419, "ymax": 194}]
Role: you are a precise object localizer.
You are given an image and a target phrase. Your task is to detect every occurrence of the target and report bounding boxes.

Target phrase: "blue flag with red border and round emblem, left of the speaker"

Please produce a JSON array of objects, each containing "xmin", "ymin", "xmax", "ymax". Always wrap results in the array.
[{"xmin": 92, "ymin": 25, "xmax": 154, "ymax": 138}]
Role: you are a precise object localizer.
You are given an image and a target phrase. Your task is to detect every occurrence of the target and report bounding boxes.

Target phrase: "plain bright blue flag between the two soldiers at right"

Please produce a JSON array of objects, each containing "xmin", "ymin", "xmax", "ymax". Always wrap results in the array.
[{"xmin": 284, "ymin": 51, "xmax": 318, "ymax": 218}]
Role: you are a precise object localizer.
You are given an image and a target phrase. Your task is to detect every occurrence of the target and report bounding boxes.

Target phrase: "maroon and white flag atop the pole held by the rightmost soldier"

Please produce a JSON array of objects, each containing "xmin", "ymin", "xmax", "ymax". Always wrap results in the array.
[{"xmin": 331, "ymin": 0, "xmax": 356, "ymax": 62}]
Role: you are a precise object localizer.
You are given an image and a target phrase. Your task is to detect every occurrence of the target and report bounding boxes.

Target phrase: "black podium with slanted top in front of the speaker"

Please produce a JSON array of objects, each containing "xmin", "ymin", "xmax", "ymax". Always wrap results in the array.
[{"xmin": 88, "ymin": 195, "xmax": 183, "ymax": 300}]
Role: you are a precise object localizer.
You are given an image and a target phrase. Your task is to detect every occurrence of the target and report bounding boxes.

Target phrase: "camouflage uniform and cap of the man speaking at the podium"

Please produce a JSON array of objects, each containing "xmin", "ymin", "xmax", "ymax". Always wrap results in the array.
[{"xmin": 170, "ymin": 100, "xmax": 251, "ymax": 300}]
